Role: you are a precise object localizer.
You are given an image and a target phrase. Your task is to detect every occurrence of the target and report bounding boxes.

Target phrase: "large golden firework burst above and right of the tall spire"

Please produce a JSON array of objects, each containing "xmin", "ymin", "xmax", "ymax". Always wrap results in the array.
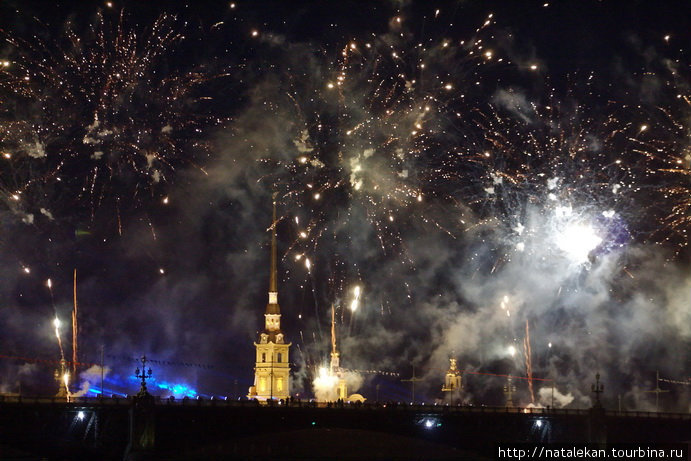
[{"xmin": 251, "ymin": 10, "xmax": 508, "ymax": 306}]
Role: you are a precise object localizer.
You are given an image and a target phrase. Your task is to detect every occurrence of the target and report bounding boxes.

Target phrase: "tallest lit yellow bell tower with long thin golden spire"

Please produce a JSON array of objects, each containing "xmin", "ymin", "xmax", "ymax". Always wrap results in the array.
[{"xmin": 247, "ymin": 196, "xmax": 291, "ymax": 400}]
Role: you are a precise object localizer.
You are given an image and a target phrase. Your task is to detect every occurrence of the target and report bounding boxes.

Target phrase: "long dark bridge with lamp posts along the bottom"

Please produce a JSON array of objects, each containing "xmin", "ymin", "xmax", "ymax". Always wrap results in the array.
[{"xmin": 0, "ymin": 396, "xmax": 691, "ymax": 460}]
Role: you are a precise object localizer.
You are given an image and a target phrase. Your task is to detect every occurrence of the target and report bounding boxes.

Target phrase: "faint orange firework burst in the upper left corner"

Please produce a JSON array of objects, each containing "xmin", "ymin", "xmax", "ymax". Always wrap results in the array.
[{"xmin": 0, "ymin": 13, "xmax": 224, "ymax": 225}]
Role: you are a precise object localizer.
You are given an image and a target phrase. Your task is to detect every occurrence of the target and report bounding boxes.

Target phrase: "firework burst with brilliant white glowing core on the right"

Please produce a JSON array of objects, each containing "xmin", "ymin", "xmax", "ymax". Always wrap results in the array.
[{"xmin": 474, "ymin": 94, "xmax": 637, "ymax": 264}]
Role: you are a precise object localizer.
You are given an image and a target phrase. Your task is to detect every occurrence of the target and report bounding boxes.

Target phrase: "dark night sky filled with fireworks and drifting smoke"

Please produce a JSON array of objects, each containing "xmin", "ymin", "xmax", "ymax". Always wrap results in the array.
[{"xmin": 0, "ymin": 0, "xmax": 691, "ymax": 412}]
